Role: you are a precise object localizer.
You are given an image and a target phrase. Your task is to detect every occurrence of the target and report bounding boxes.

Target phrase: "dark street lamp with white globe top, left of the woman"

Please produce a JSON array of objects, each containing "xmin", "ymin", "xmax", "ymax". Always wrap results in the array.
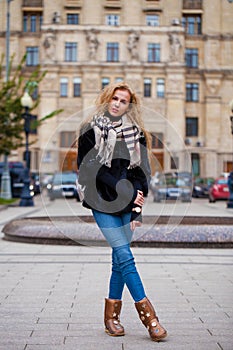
[{"xmin": 19, "ymin": 91, "xmax": 34, "ymax": 207}]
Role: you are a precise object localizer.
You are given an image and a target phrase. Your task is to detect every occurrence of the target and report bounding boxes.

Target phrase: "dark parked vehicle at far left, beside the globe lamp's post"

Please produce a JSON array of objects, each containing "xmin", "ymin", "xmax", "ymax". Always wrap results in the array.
[{"xmin": 0, "ymin": 162, "xmax": 24, "ymax": 198}]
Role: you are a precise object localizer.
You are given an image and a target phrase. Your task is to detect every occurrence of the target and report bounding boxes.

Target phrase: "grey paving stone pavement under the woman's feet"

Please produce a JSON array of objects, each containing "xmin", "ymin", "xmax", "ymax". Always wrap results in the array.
[{"xmin": 0, "ymin": 237, "xmax": 233, "ymax": 350}]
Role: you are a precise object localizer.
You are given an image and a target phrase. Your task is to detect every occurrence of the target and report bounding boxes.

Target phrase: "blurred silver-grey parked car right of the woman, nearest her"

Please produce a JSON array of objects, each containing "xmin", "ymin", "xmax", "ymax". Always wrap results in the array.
[{"xmin": 152, "ymin": 172, "xmax": 192, "ymax": 202}]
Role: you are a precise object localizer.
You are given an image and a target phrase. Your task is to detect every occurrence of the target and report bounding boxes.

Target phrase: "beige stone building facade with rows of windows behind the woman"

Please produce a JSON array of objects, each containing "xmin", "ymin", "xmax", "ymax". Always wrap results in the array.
[{"xmin": 0, "ymin": 0, "xmax": 233, "ymax": 176}]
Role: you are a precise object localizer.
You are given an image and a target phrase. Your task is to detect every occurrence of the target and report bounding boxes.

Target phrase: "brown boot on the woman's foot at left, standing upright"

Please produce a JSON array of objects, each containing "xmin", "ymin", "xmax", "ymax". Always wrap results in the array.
[{"xmin": 104, "ymin": 298, "xmax": 125, "ymax": 337}]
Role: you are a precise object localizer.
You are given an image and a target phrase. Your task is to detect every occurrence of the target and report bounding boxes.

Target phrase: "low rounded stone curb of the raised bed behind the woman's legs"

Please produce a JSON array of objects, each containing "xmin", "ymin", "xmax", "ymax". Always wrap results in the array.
[{"xmin": 2, "ymin": 216, "xmax": 233, "ymax": 248}]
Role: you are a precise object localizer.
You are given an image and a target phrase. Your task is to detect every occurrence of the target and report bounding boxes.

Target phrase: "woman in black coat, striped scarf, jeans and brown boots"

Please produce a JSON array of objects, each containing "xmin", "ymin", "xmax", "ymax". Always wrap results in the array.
[{"xmin": 78, "ymin": 82, "xmax": 167, "ymax": 341}]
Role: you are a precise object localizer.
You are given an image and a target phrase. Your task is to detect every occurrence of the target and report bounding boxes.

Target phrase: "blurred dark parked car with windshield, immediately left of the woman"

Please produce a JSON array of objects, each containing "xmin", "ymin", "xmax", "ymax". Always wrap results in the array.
[{"xmin": 47, "ymin": 172, "xmax": 79, "ymax": 200}]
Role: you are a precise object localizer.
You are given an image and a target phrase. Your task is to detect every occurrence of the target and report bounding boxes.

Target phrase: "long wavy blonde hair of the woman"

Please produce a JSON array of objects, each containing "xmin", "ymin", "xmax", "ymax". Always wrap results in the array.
[{"xmin": 80, "ymin": 81, "xmax": 151, "ymax": 147}]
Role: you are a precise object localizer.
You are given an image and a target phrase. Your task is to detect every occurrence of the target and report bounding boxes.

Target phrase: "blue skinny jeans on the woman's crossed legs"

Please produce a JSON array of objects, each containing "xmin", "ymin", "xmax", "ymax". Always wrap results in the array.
[{"xmin": 92, "ymin": 210, "xmax": 146, "ymax": 302}]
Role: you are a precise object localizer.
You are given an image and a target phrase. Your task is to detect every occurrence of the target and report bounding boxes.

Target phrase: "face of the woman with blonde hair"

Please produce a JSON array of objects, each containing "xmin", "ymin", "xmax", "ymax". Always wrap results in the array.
[{"xmin": 108, "ymin": 89, "xmax": 131, "ymax": 117}]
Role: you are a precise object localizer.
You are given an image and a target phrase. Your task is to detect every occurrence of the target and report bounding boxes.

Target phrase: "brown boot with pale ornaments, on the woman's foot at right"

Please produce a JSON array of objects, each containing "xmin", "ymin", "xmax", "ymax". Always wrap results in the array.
[{"xmin": 135, "ymin": 298, "xmax": 167, "ymax": 341}]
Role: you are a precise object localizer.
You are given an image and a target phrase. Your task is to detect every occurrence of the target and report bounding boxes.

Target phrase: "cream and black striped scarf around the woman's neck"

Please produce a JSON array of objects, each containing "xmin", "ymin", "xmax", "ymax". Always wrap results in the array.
[{"xmin": 91, "ymin": 114, "xmax": 141, "ymax": 168}]
